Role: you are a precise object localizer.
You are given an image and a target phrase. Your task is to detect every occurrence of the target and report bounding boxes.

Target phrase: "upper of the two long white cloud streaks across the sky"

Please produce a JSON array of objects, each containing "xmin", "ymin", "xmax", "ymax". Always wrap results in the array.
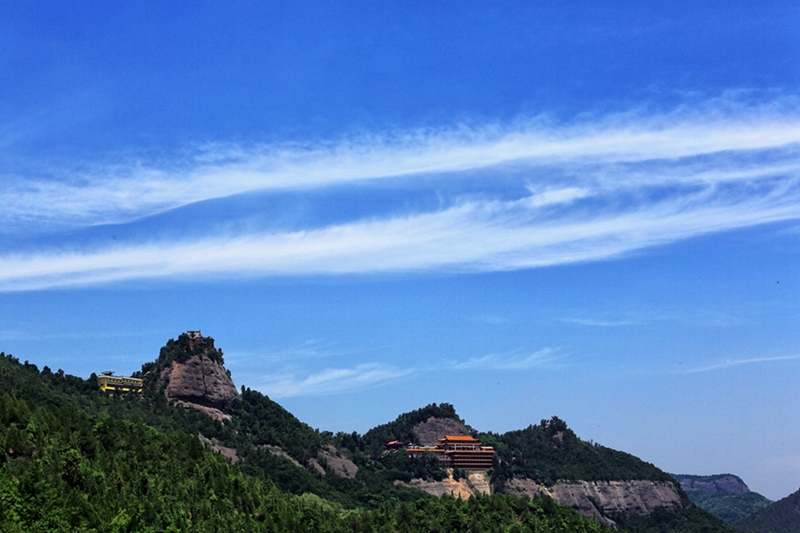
[{"xmin": 0, "ymin": 98, "xmax": 800, "ymax": 230}]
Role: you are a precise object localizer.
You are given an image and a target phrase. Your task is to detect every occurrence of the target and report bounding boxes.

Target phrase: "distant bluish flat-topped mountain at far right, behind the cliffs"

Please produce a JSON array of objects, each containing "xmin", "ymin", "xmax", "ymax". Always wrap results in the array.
[{"xmin": 673, "ymin": 474, "xmax": 772, "ymax": 524}]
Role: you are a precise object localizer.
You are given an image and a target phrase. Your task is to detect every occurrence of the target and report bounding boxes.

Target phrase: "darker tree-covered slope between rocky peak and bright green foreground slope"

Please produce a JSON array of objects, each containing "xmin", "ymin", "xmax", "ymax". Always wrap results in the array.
[{"xmin": 0, "ymin": 353, "xmax": 428, "ymax": 508}]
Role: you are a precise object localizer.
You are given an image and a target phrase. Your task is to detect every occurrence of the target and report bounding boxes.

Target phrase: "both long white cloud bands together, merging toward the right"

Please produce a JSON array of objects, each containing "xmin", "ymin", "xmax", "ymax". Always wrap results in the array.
[{"xmin": 0, "ymin": 103, "xmax": 800, "ymax": 291}]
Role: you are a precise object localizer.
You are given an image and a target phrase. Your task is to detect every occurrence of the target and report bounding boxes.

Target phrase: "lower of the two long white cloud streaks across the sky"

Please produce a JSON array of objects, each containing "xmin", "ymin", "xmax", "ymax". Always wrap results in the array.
[{"xmin": 0, "ymin": 174, "xmax": 800, "ymax": 291}]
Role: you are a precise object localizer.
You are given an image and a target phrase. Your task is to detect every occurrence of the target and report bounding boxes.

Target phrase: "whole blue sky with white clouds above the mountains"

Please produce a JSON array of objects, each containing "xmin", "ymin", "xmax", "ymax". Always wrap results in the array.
[{"xmin": 0, "ymin": 1, "xmax": 800, "ymax": 498}]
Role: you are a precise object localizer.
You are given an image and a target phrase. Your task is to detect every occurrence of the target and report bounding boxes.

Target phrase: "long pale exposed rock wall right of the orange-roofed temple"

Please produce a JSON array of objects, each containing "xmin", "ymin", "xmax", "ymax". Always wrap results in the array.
[{"xmin": 503, "ymin": 479, "xmax": 684, "ymax": 525}]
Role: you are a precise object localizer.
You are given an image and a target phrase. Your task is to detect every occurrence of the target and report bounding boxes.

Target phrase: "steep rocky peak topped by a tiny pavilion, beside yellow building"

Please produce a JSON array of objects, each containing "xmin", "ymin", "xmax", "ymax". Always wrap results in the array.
[{"xmin": 142, "ymin": 331, "xmax": 239, "ymax": 417}]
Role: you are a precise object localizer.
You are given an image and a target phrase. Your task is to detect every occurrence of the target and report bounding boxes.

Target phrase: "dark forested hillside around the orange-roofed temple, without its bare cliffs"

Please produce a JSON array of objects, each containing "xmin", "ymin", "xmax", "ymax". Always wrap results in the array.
[{"xmin": 335, "ymin": 404, "xmax": 739, "ymax": 533}]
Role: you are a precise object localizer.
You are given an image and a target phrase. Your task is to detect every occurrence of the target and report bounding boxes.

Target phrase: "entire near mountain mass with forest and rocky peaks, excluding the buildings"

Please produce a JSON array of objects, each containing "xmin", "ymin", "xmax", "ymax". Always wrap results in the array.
[{"xmin": 0, "ymin": 332, "xmax": 752, "ymax": 533}]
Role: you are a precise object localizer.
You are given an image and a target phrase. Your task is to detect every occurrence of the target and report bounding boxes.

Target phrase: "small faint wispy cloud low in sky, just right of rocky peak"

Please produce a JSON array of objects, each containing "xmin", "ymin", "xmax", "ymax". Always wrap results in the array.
[{"xmin": 252, "ymin": 363, "xmax": 414, "ymax": 398}]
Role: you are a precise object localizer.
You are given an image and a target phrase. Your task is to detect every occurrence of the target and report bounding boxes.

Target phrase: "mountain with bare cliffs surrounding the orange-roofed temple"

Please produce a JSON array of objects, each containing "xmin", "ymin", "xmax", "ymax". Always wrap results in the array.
[{"xmin": 340, "ymin": 404, "xmax": 736, "ymax": 532}]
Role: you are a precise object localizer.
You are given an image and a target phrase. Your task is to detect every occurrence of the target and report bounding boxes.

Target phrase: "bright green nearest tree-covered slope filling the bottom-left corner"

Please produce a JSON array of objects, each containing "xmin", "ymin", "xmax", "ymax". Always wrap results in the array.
[{"xmin": 0, "ymin": 392, "xmax": 310, "ymax": 532}]
